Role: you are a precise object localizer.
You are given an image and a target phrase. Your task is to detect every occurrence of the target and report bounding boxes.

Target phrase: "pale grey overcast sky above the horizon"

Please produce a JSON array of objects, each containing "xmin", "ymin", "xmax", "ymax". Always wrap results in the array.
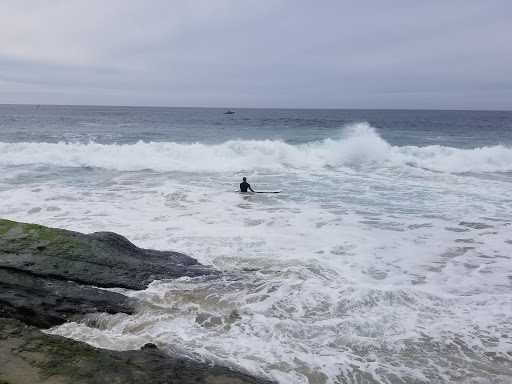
[{"xmin": 0, "ymin": 0, "xmax": 512, "ymax": 110}]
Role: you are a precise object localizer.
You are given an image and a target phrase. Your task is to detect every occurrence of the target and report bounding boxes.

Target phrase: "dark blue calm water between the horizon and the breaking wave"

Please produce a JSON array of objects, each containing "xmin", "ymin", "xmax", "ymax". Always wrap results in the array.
[{"xmin": 4, "ymin": 105, "xmax": 512, "ymax": 148}]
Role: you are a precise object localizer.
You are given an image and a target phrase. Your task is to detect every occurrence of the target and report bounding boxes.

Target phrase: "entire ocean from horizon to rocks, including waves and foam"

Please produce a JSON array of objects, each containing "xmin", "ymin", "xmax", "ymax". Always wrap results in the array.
[{"xmin": 0, "ymin": 105, "xmax": 512, "ymax": 384}]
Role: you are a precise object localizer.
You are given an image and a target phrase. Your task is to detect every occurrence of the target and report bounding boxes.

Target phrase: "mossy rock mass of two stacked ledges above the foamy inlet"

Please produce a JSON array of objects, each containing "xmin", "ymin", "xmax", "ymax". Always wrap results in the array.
[{"xmin": 0, "ymin": 220, "xmax": 217, "ymax": 328}]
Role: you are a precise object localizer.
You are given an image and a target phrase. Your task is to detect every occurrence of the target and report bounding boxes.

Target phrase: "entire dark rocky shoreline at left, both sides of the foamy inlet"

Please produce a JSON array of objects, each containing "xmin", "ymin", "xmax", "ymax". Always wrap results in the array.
[{"xmin": 0, "ymin": 219, "xmax": 269, "ymax": 384}]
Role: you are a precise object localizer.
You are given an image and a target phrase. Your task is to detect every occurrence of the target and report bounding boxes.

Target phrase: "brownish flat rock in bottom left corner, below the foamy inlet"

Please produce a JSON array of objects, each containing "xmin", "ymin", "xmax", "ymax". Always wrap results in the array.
[{"xmin": 0, "ymin": 318, "xmax": 269, "ymax": 384}]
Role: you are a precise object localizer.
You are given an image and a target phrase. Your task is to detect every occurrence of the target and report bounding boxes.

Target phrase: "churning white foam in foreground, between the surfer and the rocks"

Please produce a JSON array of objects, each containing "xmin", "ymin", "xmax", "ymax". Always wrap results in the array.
[{"xmin": 17, "ymin": 169, "xmax": 512, "ymax": 384}]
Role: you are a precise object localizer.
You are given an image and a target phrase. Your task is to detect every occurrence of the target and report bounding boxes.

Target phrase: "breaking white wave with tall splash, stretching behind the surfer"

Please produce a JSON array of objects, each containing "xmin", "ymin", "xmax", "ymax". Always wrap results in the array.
[{"xmin": 0, "ymin": 123, "xmax": 512, "ymax": 173}]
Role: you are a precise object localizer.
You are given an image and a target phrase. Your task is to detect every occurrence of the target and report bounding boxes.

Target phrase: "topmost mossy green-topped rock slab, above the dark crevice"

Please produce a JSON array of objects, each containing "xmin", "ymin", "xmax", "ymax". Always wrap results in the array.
[{"xmin": 0, "ymin": 220, "xmax": 217, "ymax": 289}]
